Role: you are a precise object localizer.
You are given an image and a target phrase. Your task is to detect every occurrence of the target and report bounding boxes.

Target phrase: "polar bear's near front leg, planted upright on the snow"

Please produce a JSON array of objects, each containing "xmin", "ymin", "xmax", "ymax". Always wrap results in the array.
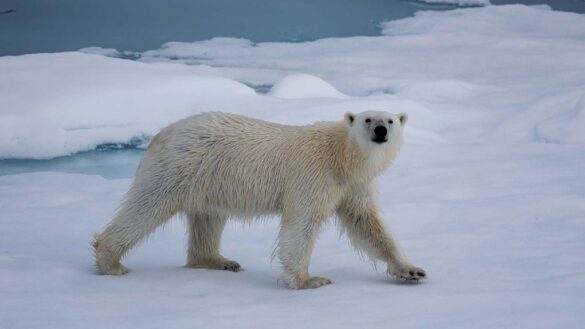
[{"xmin": 277, "ymin": 211, "xmax": 331, "ymax": 289}]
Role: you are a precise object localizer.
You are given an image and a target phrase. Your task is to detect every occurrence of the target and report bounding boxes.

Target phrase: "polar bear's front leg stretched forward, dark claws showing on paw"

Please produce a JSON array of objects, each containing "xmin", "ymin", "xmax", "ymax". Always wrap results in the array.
[{"xmin": 337, "ymin": 187, "xmax": 427, "ymax": 282}]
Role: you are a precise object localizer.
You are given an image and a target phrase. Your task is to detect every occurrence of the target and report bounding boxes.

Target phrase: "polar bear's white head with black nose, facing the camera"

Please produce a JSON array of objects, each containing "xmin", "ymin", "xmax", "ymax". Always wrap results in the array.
[{"xmin": 345, "ymin": 111, "xmax": 408, "ymax": 149}]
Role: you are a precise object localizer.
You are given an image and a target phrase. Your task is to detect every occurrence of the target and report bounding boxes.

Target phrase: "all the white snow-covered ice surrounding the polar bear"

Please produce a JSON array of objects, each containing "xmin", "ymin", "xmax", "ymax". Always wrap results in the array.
[{"xmin": 0, "ymin": 5, "xmax": 585, "ymax": 329}]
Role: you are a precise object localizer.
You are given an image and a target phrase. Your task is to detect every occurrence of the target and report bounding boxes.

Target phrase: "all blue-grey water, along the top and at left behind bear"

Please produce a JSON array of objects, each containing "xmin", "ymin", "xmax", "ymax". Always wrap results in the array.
[{"xmin": 0, "ymin": 0, "xmax": 585, "ymax": 178}]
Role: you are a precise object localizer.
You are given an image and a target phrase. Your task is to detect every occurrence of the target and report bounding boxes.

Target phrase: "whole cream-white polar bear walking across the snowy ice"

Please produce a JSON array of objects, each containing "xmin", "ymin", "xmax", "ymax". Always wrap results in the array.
[{"xmin": 94, "ymin": 111, "xmax": 426, "ymax": 289}]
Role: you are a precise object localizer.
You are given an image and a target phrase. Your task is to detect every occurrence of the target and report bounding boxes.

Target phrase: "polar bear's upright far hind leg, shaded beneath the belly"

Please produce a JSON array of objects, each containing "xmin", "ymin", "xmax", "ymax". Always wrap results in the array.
[{"xmin": 187, "ymin": 211, "xmax": 242, "ymax": 272}]
